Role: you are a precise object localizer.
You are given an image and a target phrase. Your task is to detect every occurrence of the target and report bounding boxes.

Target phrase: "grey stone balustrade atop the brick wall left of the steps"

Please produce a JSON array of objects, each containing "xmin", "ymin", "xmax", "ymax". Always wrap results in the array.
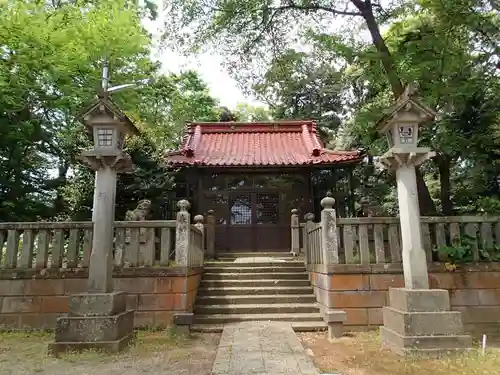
[{"xmin": 0, "ymin": 200, "xmax": 204, "ymax": 270}]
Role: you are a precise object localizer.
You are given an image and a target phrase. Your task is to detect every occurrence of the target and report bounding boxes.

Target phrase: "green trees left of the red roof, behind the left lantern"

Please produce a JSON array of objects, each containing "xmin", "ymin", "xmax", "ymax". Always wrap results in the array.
[{"xmin": 0, "ymin": 0, "xmax": 221, "ymax": 221}]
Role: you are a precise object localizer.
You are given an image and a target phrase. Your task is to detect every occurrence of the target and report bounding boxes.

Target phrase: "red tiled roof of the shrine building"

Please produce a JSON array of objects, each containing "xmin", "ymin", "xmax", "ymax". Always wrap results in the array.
[{"xmin": 166, "ymin": 121, "xmax": 361, "ymax": 167}]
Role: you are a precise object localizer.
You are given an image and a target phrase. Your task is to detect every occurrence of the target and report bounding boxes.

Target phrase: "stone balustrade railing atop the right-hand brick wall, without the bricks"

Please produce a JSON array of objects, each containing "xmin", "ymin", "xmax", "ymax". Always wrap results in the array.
[{"xmin": 299, "ymin": 214, "xmax": 500, "ymax": 264}]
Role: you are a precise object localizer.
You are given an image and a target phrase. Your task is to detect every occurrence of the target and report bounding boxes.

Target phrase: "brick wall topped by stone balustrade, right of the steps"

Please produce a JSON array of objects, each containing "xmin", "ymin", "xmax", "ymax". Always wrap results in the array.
[{"xmin": 291, "ymin": 206, "xmax": 500, "ymax": 338}]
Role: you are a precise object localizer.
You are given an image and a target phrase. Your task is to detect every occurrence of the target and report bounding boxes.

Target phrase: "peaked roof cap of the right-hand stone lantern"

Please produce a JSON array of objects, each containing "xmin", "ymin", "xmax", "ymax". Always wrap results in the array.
[{"xmin": 376, "ymin": 84, "xmax": 436, "ymax": 133}]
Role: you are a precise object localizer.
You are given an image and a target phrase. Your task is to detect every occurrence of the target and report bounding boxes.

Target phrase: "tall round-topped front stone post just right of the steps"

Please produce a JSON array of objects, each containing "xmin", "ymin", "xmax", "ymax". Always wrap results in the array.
[{"xmin": 321, "ymin": 192, "xmax": 339, "ymax": 265}]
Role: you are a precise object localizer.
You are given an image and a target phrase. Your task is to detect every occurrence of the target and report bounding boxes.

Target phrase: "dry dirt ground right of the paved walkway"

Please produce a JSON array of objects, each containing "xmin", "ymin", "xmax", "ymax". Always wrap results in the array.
[{"xmin": 298, "ymin": 331, "xmax": 500, "ymax": 375}]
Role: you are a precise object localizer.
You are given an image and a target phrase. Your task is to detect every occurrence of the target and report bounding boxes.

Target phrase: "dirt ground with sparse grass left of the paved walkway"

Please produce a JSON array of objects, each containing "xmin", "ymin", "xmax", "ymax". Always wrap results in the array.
[{"xmin": 0, "ymin": 331, "xmax": 220, "ymax": 375}]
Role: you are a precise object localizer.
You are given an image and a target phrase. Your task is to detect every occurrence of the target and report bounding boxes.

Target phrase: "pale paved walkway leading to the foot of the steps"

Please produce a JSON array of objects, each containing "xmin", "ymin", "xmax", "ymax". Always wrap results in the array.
[{"xmin": 212, "ymin": 322, "xmax": 319, "ymax": 375}]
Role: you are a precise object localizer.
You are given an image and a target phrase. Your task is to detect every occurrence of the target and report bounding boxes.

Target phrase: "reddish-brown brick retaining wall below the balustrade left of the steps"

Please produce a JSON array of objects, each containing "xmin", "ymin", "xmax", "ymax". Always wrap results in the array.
[{"xmin": 0, "ymin": 267, "xmax": 203, "ymax": 330}]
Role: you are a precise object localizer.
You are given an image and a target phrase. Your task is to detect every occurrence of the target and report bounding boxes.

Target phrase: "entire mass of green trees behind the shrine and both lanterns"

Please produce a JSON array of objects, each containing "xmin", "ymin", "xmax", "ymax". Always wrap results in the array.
[{"xmin": 0, "ymin": 0, "xmax": 500, "ymax": 223}]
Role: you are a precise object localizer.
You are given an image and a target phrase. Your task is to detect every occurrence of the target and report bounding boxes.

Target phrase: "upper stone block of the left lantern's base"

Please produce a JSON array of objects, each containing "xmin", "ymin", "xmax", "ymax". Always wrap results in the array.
[{"xmin": 68, "ymin": 292, "xmax": 127, "ymax": 316}]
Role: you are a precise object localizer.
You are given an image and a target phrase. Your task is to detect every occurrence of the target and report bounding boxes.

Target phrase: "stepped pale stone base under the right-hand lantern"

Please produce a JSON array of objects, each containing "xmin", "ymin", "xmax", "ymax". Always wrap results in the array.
[{"xmin": 381, "ymin": 288, "xmax": 472, "ymax": 356}]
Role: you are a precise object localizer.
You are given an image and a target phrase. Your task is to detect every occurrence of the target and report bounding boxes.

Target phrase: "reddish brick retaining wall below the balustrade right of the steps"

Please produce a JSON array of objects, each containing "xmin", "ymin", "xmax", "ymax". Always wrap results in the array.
[{"xmin": 308, "ymin": 263, "xmax": 500, "ymax": 331}]
